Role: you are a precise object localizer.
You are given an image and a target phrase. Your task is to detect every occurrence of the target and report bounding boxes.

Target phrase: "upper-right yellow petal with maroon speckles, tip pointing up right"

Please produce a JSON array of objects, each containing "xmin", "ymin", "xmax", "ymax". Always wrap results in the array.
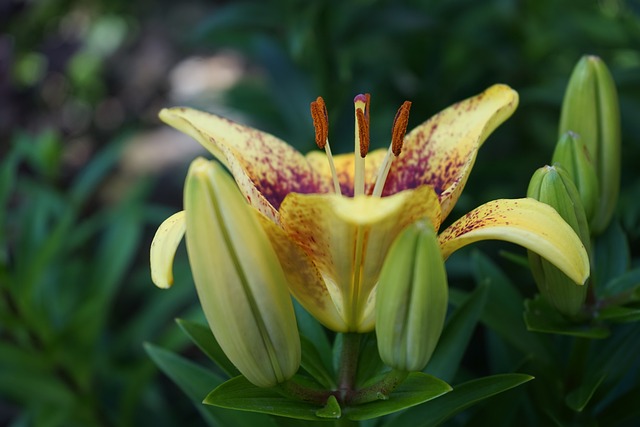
[{"xmin": 383, "ymin": 85, "xmax": 518, "ymax": 219}]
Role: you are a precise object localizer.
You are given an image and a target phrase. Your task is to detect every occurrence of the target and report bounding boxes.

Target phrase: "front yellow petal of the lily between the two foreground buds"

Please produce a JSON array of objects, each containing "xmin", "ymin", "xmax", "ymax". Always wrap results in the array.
[{"xmin": 280, "ymin": 186, "xmax": 440, "ymax": 332}]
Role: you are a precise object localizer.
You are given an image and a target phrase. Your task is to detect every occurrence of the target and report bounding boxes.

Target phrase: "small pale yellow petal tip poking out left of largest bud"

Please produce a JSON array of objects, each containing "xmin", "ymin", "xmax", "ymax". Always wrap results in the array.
[{"xmin": 149, "ymin": 211, "xmax": 186, "ymax": 288}]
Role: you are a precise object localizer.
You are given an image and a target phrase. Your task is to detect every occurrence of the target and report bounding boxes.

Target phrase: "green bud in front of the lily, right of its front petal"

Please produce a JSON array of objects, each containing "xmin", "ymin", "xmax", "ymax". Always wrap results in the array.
[{"xmin": 376, "ymin": 221, "xmax": 448, "ymax": 371}]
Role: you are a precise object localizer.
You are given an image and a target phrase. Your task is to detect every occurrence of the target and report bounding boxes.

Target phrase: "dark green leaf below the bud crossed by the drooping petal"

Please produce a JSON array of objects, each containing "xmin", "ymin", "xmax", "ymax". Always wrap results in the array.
[{"xmin": 524, "ymin": 295, "xmax": 609, "ymax": 339}]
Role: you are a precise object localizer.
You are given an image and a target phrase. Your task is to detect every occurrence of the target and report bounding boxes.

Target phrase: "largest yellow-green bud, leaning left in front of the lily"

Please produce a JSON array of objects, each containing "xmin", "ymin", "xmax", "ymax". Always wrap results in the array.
[{"xmin": 184, "ymin": 158, "xmax": 300, "ymax": 387}]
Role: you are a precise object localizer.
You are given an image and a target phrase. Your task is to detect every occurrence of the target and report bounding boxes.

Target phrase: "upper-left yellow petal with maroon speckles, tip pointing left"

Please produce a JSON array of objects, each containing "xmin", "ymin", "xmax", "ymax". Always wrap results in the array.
[{"xmin": 160, "ymin": 107, "xmax": 331, "ymax": 220}]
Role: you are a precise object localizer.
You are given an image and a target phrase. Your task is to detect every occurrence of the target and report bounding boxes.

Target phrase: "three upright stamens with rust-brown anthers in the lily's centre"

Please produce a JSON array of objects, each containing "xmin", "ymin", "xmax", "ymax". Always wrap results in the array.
[{"xmin": 311, "ymin": 93, "xmax": 411, "ymax": 197}]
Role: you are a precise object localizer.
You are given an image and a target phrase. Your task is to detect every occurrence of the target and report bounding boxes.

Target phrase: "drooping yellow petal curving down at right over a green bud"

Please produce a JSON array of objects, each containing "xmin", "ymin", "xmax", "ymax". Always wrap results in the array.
[{"xmin": 439, "ymin": 198, "xmax": 589, "ymax": 284}]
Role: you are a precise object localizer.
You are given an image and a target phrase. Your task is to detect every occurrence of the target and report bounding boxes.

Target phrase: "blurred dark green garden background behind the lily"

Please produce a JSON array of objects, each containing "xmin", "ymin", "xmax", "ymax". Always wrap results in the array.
[{"xmin": 0, "ymin": 0, "xmax": 640, "ymax": 426}]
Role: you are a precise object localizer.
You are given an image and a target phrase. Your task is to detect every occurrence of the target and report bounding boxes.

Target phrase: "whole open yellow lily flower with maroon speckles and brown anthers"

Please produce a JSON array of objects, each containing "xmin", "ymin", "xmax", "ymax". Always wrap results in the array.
[{"xmin": 151, "ymin": 85, "xmax": 589, "ymax": 332}]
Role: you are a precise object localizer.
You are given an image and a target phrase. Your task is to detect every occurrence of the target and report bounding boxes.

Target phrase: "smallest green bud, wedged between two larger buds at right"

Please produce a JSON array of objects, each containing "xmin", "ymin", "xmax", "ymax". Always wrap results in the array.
[{"xmin": 552, "ymin": 131, "xmax": 599, "ymax": 222}]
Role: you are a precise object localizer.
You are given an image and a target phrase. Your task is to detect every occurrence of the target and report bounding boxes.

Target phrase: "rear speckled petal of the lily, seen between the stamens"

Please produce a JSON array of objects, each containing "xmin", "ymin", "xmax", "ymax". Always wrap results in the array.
[{"xmin": 307, "ymin": 149, "xmax": 387, "ymax": 197}]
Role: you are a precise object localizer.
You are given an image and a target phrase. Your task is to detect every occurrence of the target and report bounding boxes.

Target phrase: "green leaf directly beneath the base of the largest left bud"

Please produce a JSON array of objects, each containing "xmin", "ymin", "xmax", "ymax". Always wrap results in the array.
[{"xmin": 204, "ymin": 376, "xmax": 323, "ymax": 421}]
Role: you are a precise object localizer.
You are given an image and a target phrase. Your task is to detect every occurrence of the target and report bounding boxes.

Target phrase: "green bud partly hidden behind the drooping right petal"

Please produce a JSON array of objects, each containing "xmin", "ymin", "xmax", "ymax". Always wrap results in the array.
[{"xmin": 527, "ymin": 166, "xmax": 589, "ymax": 316}]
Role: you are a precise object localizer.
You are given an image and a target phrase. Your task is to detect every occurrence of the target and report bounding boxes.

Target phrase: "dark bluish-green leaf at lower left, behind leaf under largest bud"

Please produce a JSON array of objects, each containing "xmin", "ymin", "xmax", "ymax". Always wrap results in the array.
[{"xmin": 144, "ymin": 343, "xmax": 274, "ymax": 427}]
